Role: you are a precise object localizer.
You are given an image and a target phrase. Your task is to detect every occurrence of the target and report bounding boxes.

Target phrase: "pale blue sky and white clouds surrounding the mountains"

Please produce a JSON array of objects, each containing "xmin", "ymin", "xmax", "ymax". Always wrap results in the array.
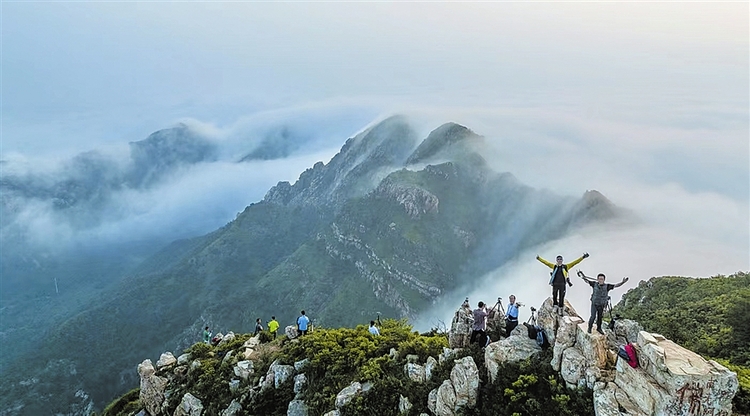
[{"xmin": 0, "ymin": 1, "xmax": 750, "ymax": 319}]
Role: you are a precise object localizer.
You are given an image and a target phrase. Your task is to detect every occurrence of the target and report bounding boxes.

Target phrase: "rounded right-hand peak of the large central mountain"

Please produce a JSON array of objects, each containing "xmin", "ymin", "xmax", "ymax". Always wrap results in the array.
[{"xmin": 406, "ymin": 122, "xmax": 482, "ymax": 164}]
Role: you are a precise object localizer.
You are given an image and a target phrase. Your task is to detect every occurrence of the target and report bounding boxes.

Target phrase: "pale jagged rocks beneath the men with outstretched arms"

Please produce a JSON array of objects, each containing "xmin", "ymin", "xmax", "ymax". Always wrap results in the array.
[{"xmin": 450, "ymin": 298, "xmax": 739, "ymax": 416}]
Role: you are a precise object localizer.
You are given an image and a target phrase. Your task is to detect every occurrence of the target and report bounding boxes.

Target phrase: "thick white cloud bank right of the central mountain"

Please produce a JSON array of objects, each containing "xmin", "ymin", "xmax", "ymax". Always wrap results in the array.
[{"xmin": 417, "ymin": 106, "xmax": 750, "ymax": 329}]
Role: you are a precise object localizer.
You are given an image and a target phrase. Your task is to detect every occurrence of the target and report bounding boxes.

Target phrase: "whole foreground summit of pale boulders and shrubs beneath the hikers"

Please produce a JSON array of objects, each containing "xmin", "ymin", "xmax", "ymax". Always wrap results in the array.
[{"xmin": 104, "ymin": 299, "xmax": 738, "ymax": 416}]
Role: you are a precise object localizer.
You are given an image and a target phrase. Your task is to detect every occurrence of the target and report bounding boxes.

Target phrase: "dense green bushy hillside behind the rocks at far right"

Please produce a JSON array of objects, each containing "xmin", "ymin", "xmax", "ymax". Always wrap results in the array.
[{"xmin": 614, "ymin": 272, "xmax": 750, "ymax": 414}]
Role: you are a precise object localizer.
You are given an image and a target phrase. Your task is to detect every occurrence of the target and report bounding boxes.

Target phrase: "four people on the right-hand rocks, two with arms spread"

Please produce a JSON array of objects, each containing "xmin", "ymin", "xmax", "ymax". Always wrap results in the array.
[{"xmin": 466, "ymin": 253, "xmax": 628, "ymax": 345}]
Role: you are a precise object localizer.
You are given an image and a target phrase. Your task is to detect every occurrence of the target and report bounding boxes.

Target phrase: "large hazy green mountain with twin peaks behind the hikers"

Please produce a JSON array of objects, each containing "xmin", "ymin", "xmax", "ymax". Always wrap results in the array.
[{"xmin": 0, "ymin": 116, "xmax": 621, "ymax": 414}]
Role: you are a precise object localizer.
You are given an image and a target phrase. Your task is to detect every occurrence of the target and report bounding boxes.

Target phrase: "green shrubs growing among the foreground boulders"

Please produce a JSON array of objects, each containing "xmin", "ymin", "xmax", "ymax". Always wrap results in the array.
[{"xmin": 104, "ymin": 319, "xmax": 593, "ymax": 416}]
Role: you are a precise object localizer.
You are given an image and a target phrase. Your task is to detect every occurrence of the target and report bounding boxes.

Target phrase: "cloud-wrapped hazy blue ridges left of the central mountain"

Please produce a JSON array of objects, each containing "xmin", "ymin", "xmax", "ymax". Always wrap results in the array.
[{"xmin": 2, "ymin": 105, "xmax": 372, "ymax": 252}]
